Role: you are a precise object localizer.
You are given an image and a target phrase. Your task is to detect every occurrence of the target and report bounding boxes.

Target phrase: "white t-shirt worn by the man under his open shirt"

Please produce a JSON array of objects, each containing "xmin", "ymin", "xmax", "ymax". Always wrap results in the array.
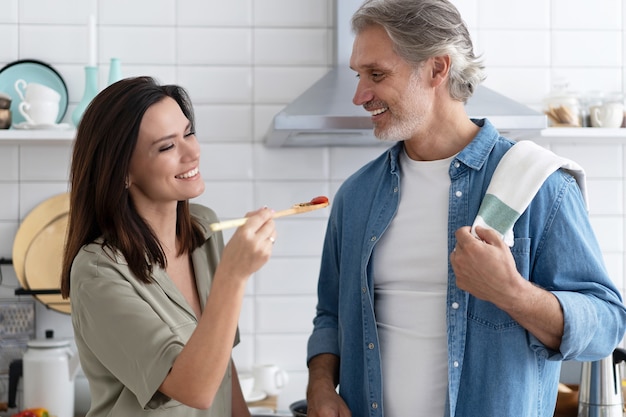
[{"xmin": 373, "ymin": 148, "xmax": 454, "ymax": 417}]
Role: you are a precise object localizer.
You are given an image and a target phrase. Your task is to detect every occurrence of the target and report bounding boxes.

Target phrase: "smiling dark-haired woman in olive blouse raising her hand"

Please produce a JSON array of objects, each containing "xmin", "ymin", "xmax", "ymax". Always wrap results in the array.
[{"xmin": 61, "ymin": 77, "xmax": 276, "ymax": 417}]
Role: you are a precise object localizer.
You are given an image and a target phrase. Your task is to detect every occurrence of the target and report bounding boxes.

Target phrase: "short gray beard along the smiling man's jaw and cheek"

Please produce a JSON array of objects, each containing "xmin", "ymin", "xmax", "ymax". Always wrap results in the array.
[{"xmin": 374, "ymin": 71, "xmax": 424, "ymax": 142}]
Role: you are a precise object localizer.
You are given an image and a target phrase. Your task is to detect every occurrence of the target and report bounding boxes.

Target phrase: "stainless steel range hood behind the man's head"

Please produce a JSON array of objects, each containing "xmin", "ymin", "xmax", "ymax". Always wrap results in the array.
[{"xmin": 265, "ymin": 0, "xmax": 547, "ymax": 147}]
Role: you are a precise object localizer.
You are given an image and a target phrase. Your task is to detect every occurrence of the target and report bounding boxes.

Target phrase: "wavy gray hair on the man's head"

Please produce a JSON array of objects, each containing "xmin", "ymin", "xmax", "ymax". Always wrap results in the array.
[{"xmin": 352, "ymin": 0, "xmax": 485, "ymax": 102}]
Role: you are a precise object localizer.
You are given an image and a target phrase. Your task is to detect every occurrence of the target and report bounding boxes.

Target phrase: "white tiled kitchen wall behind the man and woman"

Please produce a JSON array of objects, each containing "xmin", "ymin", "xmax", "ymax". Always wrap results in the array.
[{"xmin": 0, "ymin": 0, "xmax": 626, "ymax": 409}]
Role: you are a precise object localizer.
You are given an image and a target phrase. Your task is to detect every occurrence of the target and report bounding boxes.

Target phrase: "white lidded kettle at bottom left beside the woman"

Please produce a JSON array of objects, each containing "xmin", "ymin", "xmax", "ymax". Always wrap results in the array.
[{"xmin": 22, "ymin": 338, "xmax": 80, "ymax": 417}]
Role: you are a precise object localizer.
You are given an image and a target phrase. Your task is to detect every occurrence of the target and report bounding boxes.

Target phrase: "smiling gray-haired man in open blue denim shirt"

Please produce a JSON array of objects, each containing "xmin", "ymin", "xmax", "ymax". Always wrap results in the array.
[{"xmin": 307, "ymin": 0, "xmax": 626, "ymax": 417}]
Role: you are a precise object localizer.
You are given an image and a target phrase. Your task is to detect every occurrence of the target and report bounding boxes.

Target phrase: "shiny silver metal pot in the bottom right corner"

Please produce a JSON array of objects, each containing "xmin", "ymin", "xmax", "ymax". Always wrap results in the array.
[{"xmin": 578, "ymin": 348, "xmax": 626, "ymax": 417}]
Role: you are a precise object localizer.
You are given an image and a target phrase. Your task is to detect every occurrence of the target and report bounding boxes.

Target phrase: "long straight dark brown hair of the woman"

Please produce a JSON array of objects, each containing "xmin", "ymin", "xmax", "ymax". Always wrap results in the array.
[{"xmin": 61, "ymin": 77, "xmax": 204, "ymax": 298}]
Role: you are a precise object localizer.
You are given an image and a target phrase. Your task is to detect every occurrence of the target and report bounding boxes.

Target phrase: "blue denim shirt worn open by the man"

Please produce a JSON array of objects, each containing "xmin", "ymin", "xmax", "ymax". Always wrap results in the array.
[{"xmin": 307, "ymin": 119, "xmax": 626, "ymax": 417}]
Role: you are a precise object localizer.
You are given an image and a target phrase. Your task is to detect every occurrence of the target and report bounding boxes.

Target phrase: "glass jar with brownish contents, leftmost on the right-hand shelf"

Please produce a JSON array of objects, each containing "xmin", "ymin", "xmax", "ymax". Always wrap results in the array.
[{"xmin": 543, "ymin": 78, "xmax": 583, "ymax": 127}]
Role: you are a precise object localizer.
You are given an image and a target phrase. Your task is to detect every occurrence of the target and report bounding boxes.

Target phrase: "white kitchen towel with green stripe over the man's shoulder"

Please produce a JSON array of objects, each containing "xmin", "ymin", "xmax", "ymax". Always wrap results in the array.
[{"xmin": 472, "ymin": 140, "xmax": 589, "ymax": 246}]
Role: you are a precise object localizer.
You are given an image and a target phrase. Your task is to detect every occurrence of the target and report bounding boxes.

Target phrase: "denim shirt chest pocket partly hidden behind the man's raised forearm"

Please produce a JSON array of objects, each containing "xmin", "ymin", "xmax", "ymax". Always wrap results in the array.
[{"xmin": 467, "ymin": 238, "xmax": 530, "ymax": 331}]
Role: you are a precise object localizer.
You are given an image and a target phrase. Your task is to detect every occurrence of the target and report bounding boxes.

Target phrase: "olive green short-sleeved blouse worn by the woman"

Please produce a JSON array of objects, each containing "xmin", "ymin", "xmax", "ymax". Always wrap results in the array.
[{"xmin": 70, "ymin": 204, "xmax": 239, "ymax": 417}]
